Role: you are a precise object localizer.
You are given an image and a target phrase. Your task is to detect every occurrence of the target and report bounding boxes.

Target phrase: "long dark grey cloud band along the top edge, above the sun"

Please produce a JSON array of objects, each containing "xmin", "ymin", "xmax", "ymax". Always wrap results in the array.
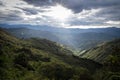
[{"xmin": 24, "ymin": 0, "xmax": 120, "ymax": 12}]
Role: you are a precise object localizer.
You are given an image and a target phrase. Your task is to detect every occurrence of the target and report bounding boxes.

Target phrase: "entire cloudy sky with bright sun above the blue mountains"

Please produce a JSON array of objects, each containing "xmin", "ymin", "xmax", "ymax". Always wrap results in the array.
[{"xmin": 0, "ymin": 0, "xmax": 120, "ymax": 28}]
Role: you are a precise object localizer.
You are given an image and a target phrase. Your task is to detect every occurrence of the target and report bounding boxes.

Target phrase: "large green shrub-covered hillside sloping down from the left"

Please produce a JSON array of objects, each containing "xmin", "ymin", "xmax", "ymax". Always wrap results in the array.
[{"xmin": 0, "ymin": 29, "xmax": 102, "ymax": 80}]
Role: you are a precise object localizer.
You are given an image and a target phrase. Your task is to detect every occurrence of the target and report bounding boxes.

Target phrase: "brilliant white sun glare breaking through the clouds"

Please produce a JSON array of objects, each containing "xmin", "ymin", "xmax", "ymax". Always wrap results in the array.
[{"xmin": 45, "ymin": 4, "xmax": 73, "ymax": 21}]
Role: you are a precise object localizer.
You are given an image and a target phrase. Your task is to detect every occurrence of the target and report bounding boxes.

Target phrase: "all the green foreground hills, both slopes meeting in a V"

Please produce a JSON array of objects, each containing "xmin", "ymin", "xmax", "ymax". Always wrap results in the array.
[{"xmin": 0, "ymin": 29, "xmax": 120, "ymax": 80}]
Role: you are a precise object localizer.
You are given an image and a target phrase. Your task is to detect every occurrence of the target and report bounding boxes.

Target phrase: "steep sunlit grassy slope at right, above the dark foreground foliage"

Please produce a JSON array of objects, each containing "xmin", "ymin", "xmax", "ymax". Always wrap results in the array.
[{"xmin": 80, "ymin": 39, "xmax": 120, "ymax": 63}]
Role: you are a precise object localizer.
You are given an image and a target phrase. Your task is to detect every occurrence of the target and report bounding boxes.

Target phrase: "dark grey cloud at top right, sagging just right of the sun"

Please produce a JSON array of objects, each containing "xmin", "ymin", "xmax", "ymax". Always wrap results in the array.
[{"xmin": 65, "ymin": 0, "xmax": 120, "ymax": 12}]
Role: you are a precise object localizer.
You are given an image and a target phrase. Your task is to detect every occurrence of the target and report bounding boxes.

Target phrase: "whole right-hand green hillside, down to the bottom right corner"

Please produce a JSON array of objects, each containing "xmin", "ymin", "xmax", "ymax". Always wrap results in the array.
[{"xmin": 81, "ymin": 39, "xmax": 120, "ymax": 80}]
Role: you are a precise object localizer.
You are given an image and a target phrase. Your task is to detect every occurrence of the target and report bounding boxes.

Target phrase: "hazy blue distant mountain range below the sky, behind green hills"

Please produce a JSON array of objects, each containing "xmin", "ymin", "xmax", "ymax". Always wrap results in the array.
[{"xmin": 3, "ymin": 25, "xmax": 120, "ymax": 50}]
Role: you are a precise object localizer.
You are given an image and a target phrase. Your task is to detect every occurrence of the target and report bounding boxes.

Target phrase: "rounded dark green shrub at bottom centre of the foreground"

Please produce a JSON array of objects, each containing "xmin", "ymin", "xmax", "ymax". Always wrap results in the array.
[{"xmin": 39, "ymin": 63, "xmax": 73, "ymax": 80}]
